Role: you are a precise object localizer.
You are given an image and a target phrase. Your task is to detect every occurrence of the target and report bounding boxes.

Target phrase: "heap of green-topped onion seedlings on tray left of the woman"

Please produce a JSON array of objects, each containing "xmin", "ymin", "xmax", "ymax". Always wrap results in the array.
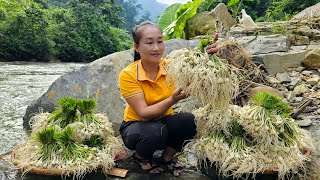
[{"xmin": 13, "ymin": 97, "xmax": 122, "ymax": 179}]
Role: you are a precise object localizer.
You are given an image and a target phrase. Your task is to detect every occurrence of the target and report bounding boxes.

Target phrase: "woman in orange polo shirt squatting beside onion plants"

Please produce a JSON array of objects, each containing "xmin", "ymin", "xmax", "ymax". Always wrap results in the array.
[{"xmin": 119, "ymin": 22, "xmax": 196, "ymax": 176}]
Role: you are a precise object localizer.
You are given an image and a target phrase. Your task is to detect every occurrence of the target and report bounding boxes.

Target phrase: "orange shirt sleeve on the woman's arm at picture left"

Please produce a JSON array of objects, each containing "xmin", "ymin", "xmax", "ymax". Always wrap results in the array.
[{"xmin": 119, "ymin": 71, "xmax": 143, "ymax": 99}]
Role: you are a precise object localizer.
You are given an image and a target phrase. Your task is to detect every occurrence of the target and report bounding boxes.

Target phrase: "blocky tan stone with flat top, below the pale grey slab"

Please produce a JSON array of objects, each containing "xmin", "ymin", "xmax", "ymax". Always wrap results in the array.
[{"xmin": 253, "ymin": 50, "xmax": 307, "ymax": 75}]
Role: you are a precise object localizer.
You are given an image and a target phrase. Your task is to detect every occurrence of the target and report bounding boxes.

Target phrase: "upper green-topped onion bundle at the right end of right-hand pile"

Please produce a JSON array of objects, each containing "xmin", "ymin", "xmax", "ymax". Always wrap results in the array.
[{"xmin": 238, "ymin": 92, "xmax": 312, "ymax": 147}]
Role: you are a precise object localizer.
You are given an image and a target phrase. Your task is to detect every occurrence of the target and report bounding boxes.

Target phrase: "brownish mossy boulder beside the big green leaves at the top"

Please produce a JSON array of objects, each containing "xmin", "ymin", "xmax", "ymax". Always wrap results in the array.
[{"xmin": 186, "ymin": 3, "xmax": 237, "ymax": 39}]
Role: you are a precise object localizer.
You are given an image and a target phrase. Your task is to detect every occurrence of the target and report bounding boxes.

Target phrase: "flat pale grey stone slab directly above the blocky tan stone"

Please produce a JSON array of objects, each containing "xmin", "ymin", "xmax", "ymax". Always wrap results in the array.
[{"xmin": 236, "ymin": 34, "xmax": 288, "ymax": 55}]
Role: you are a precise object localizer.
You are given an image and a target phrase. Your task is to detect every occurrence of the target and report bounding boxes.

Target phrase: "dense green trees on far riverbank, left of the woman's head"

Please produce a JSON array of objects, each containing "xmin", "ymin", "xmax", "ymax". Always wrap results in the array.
[{"xmin": 0, "ymin": 0, "xmax": 147, "ymax": 62}]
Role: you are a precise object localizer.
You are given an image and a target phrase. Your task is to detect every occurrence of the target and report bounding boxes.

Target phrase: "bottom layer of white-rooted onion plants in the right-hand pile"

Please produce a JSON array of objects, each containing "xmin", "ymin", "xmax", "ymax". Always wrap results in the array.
[{"xmin": 184, "ymin": 107, "xmax": 313, "ymax": 179}]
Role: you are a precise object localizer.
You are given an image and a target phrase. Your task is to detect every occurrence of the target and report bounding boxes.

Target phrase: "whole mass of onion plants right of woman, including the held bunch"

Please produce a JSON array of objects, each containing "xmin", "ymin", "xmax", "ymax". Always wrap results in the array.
[{"xmin": 168, "ymin": 40, "xmax": 313, "ymax": 179}]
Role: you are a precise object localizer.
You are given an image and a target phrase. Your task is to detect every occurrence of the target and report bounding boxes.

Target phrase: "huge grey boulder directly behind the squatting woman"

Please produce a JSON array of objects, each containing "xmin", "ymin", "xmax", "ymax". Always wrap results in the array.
[{"xmin": 23, "ymin": 39, "xmax": 198, "ymax": 132}]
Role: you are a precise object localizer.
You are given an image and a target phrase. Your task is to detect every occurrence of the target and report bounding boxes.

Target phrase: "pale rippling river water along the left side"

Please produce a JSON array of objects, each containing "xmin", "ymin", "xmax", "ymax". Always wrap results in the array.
[{"xmin": 0, "ymin": 62, "xmax": 85, "ymax": 180}]
